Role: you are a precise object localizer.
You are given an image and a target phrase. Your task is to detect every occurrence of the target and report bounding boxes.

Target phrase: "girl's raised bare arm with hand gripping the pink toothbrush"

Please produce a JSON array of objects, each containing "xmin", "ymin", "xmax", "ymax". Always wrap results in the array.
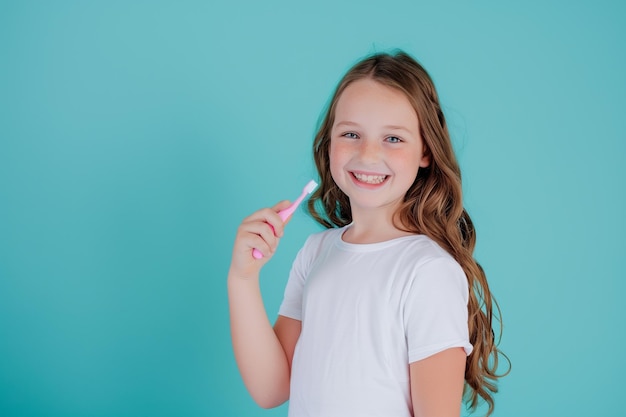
[{"xmin": 228, "ymin": 202, "xmax": 299, "ymax": 408}]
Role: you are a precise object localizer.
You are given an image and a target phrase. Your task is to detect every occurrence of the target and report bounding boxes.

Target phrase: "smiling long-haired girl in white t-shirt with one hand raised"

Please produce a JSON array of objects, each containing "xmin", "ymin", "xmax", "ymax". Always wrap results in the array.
[{"xmin": 228, "ymin": 52, "xmax": 500, "ymax": 417}]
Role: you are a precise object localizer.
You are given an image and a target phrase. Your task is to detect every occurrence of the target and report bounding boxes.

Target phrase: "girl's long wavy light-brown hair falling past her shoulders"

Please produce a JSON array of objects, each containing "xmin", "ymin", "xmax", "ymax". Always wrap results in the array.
[{"xmin": 308, "ymin": 51, "xmax": 510, "ymax": 416}]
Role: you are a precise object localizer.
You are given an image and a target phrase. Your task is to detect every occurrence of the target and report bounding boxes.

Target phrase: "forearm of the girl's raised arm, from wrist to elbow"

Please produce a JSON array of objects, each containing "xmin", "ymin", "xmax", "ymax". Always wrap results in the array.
[{"xmin": 228, "ymin": 275, "xmax": 290, "ymax": 408}]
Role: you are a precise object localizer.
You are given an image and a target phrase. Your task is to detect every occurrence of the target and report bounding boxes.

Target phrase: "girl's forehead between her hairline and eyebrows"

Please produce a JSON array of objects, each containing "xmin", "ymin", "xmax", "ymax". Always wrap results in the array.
[{"xmin": 335, "ymin": 78, "xmax": 418, "ymax": 127}]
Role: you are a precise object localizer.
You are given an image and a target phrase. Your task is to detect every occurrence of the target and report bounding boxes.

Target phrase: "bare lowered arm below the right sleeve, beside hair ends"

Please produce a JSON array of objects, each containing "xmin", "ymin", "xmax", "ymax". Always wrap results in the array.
[{"xmin": 409, "ymin": 348, "xmax": 466, "ymax": 417}]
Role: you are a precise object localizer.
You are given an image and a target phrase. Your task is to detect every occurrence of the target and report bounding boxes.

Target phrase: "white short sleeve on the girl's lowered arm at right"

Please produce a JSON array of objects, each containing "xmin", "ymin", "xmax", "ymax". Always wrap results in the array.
[{"xmin": 403, "ymin": 257, "xmax": 472, "ymax": 363}]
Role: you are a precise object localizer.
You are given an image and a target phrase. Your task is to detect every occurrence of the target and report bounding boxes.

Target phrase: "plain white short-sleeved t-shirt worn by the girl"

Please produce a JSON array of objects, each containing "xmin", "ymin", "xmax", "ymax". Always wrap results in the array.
[{"xmin": 279, "ymin": 226, "xmax": 472, "ymax": 417}]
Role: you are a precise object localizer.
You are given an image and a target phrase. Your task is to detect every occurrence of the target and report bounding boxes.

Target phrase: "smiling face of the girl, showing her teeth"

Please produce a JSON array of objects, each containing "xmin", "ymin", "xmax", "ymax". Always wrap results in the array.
[{"xmin": 329, "ymin": 79, "xmax": 429, "ymax": 218}]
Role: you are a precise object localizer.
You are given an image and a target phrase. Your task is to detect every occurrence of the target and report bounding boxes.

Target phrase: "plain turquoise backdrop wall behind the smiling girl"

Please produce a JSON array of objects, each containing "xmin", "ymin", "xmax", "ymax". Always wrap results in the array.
[{"xmin": 0, "ymin": 0, "xmax": 626, "ymax": 417}]
